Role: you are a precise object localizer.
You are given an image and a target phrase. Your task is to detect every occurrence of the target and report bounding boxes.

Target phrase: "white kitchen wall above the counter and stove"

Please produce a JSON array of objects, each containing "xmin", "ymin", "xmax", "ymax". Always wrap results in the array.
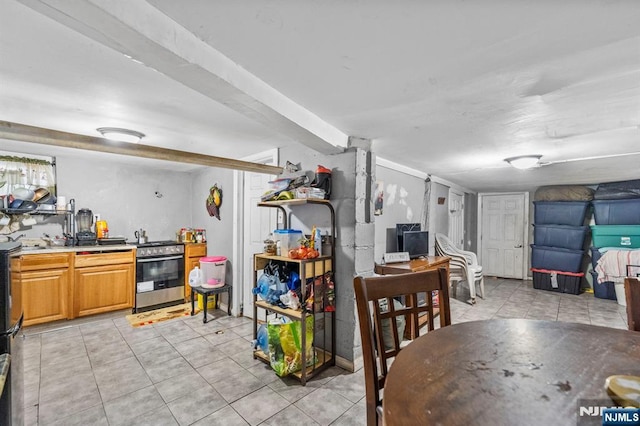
[{"xmin": 5, "ymin": 155, "xmax": 195, "ymax": 242}]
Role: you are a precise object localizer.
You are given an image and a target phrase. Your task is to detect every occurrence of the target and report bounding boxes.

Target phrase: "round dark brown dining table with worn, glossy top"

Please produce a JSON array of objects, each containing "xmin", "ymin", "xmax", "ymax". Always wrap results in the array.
[{"xmin": 383, "ymin": 319, "xmax": 640, "ymax": 426}]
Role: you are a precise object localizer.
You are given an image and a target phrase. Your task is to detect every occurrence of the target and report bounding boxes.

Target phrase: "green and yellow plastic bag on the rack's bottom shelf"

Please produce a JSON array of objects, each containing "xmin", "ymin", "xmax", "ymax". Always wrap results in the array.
[{"xmin": 267, "ymin": 315, "xmax": 315, "ymax": 377}]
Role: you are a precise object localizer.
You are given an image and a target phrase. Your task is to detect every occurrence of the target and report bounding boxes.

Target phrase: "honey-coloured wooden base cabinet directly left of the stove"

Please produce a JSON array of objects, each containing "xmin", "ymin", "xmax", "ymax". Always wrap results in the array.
[{"xmin": 73, "ymin": 250, "xmax": 135, "ymax": 318}]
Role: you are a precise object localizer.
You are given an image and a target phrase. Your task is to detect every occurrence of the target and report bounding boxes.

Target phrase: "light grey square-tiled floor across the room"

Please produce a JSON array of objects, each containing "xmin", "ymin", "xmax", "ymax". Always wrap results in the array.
[{"xmin": 24, "ymin": 278, "xmax": 626, "ymax": 426}]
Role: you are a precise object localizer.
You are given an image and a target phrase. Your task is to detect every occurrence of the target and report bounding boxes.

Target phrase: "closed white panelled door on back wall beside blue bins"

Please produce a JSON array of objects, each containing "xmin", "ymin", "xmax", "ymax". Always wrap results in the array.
[{"xmin": 478, "ymin": 193, "xmax": 529, "ymax": 279}]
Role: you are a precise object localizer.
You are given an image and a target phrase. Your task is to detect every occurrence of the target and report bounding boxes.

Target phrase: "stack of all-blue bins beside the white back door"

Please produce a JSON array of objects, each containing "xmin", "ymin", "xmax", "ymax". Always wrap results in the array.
[{"xmin": 531, "ymin": 186, "xmax": 593, "ymax": 294}]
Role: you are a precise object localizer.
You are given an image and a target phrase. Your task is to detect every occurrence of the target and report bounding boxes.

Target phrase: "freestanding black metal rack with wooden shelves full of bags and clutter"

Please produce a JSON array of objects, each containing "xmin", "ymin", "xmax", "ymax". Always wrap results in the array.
[{"xmin": 253, "ymin": 199, "xmax": 336, "ymax": 385}]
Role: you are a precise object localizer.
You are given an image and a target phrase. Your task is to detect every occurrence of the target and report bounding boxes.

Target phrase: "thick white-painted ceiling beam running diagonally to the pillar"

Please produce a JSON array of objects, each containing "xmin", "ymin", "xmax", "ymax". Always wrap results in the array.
[{"xmin": 19, "ymin": 0, "xmax": 348, "ymax": 154}]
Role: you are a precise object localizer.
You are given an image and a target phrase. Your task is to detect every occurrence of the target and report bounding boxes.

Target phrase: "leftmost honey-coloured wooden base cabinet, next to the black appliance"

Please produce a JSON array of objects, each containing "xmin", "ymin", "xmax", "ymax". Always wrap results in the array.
[{"xmin": 11, "ymin": 253, "xmax": 72, "ymax": 326}]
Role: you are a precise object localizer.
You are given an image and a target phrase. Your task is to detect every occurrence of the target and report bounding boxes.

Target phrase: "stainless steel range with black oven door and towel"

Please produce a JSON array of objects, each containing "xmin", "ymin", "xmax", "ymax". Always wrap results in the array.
[{"xmin": 133, "ymin": 241, "xmax": 184, "ymax": 312}]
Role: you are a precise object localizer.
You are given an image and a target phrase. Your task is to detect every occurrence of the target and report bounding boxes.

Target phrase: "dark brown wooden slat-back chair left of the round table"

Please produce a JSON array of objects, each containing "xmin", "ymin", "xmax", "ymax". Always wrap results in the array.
[{"xmin": 353, "ymin": 268, "xmax": 451, "ymax": 426}]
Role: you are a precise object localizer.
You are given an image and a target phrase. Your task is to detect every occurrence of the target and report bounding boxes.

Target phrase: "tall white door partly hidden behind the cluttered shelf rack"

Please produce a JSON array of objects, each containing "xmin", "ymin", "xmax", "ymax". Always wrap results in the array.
[{"xmin": 241, "ymin": 151, "xmax": 278, "ymax": 318}]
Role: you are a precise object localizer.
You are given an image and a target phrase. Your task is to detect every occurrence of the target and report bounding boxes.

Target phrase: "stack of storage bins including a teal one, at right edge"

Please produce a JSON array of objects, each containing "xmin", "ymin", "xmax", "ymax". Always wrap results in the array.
[{"xmin": 591, "ymin": 180, "xmax": 640, "ymax": 304}]
